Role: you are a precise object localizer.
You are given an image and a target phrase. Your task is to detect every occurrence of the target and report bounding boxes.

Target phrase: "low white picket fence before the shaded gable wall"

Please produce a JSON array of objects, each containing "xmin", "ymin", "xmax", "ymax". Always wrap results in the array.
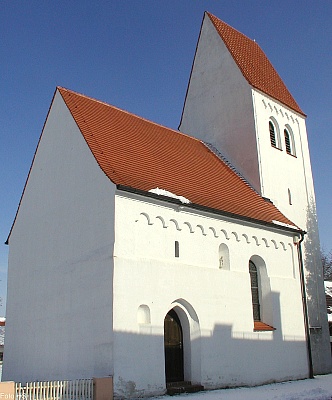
[{"xmin": 15, "ymin": 379, "xmax": 93, "ymax": 400}]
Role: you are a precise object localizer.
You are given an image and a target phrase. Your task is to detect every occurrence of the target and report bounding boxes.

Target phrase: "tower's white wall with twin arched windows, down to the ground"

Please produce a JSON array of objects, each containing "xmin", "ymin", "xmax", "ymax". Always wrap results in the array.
[{"xmin": 253, "ymin": 90, "xmax": 331, "ymax": 374}]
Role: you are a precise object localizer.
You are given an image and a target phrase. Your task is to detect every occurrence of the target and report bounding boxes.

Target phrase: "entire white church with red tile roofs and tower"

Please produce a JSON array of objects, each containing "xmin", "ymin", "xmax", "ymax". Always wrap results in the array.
[{"xmin": 3, "ymin": 13, "xmax": 331, "ymax": 399}]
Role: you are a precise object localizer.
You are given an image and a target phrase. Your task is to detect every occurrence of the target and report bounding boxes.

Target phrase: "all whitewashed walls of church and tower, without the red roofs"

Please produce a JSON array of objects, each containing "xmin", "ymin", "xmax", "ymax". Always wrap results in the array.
[{"xmin": 3, "ymin": 10, "xmax": 328, "ymax": 398}]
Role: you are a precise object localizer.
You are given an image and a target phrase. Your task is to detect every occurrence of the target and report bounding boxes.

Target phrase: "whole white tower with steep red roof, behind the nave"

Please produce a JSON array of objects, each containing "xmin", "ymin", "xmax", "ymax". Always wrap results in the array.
[{"xmin": 179, "ymin": 13, "xmax": 331, "ymax": 374}]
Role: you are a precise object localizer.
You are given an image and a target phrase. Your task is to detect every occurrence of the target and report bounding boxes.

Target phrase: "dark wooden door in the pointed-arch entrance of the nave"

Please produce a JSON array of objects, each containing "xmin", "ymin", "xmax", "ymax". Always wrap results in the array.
[{"xmin": 164, "ymin": 309, "xmax": 184, "ymax": 383}]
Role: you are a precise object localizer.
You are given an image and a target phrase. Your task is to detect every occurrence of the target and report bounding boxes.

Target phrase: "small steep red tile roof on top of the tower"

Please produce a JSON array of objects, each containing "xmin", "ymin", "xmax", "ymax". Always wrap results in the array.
[{"xmin": 207, "ymin": 13, "xmax": 305, "ymax": 116}]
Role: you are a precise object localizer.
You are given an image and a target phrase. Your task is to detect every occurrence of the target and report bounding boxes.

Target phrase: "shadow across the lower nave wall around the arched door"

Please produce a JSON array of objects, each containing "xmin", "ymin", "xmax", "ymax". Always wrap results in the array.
[{"xmin": 114, "ymin": 293, "xmax": 308, "ymax": 399}]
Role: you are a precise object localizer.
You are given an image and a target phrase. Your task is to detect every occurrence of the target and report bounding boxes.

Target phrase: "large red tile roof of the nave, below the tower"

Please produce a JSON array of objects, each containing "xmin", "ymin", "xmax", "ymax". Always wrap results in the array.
[{"xmin": 58, "ymin": 88, "xmax": 294, "ymax": 231}]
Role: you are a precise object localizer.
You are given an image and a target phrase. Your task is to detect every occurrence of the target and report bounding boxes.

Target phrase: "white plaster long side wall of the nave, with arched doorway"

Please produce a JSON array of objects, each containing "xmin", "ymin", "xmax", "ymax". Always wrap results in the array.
[{"xmin": 113, "ymin": 192, "xmax": 308, "ymax": 398}]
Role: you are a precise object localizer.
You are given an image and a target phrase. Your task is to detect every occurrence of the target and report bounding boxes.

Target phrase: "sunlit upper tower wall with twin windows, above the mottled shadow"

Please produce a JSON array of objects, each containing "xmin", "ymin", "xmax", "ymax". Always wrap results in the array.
[{"xmin": 253, "ymin": 90, "xmax": 315, "ymax": 230}]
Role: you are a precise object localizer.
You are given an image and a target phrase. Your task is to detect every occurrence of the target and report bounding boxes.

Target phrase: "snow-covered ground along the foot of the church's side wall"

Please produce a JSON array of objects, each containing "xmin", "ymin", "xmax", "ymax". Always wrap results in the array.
[{"xmin": 154, "ymin": 375, "xmax": 332, "ymax": 400}]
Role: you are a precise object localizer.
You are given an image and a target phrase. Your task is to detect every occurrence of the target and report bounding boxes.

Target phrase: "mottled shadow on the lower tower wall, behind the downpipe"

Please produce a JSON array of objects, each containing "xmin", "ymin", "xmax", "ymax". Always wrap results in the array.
[{"xmin": 302, "ymin": 201, "xmax": 331, "ymax": 374}]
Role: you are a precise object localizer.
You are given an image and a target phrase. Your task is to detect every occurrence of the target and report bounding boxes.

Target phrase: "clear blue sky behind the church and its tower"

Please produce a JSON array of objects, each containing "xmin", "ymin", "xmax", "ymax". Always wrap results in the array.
[{"xmin": 0, "ymin": 0, "xmax": 332, "ymax": 315}]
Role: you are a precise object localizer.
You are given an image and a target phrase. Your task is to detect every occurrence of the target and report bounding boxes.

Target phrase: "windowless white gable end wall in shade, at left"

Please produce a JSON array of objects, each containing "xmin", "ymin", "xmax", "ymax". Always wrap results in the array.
[{"xmin": 3, "ymin": 93, "xmax": 115, "ymax": 382}]
